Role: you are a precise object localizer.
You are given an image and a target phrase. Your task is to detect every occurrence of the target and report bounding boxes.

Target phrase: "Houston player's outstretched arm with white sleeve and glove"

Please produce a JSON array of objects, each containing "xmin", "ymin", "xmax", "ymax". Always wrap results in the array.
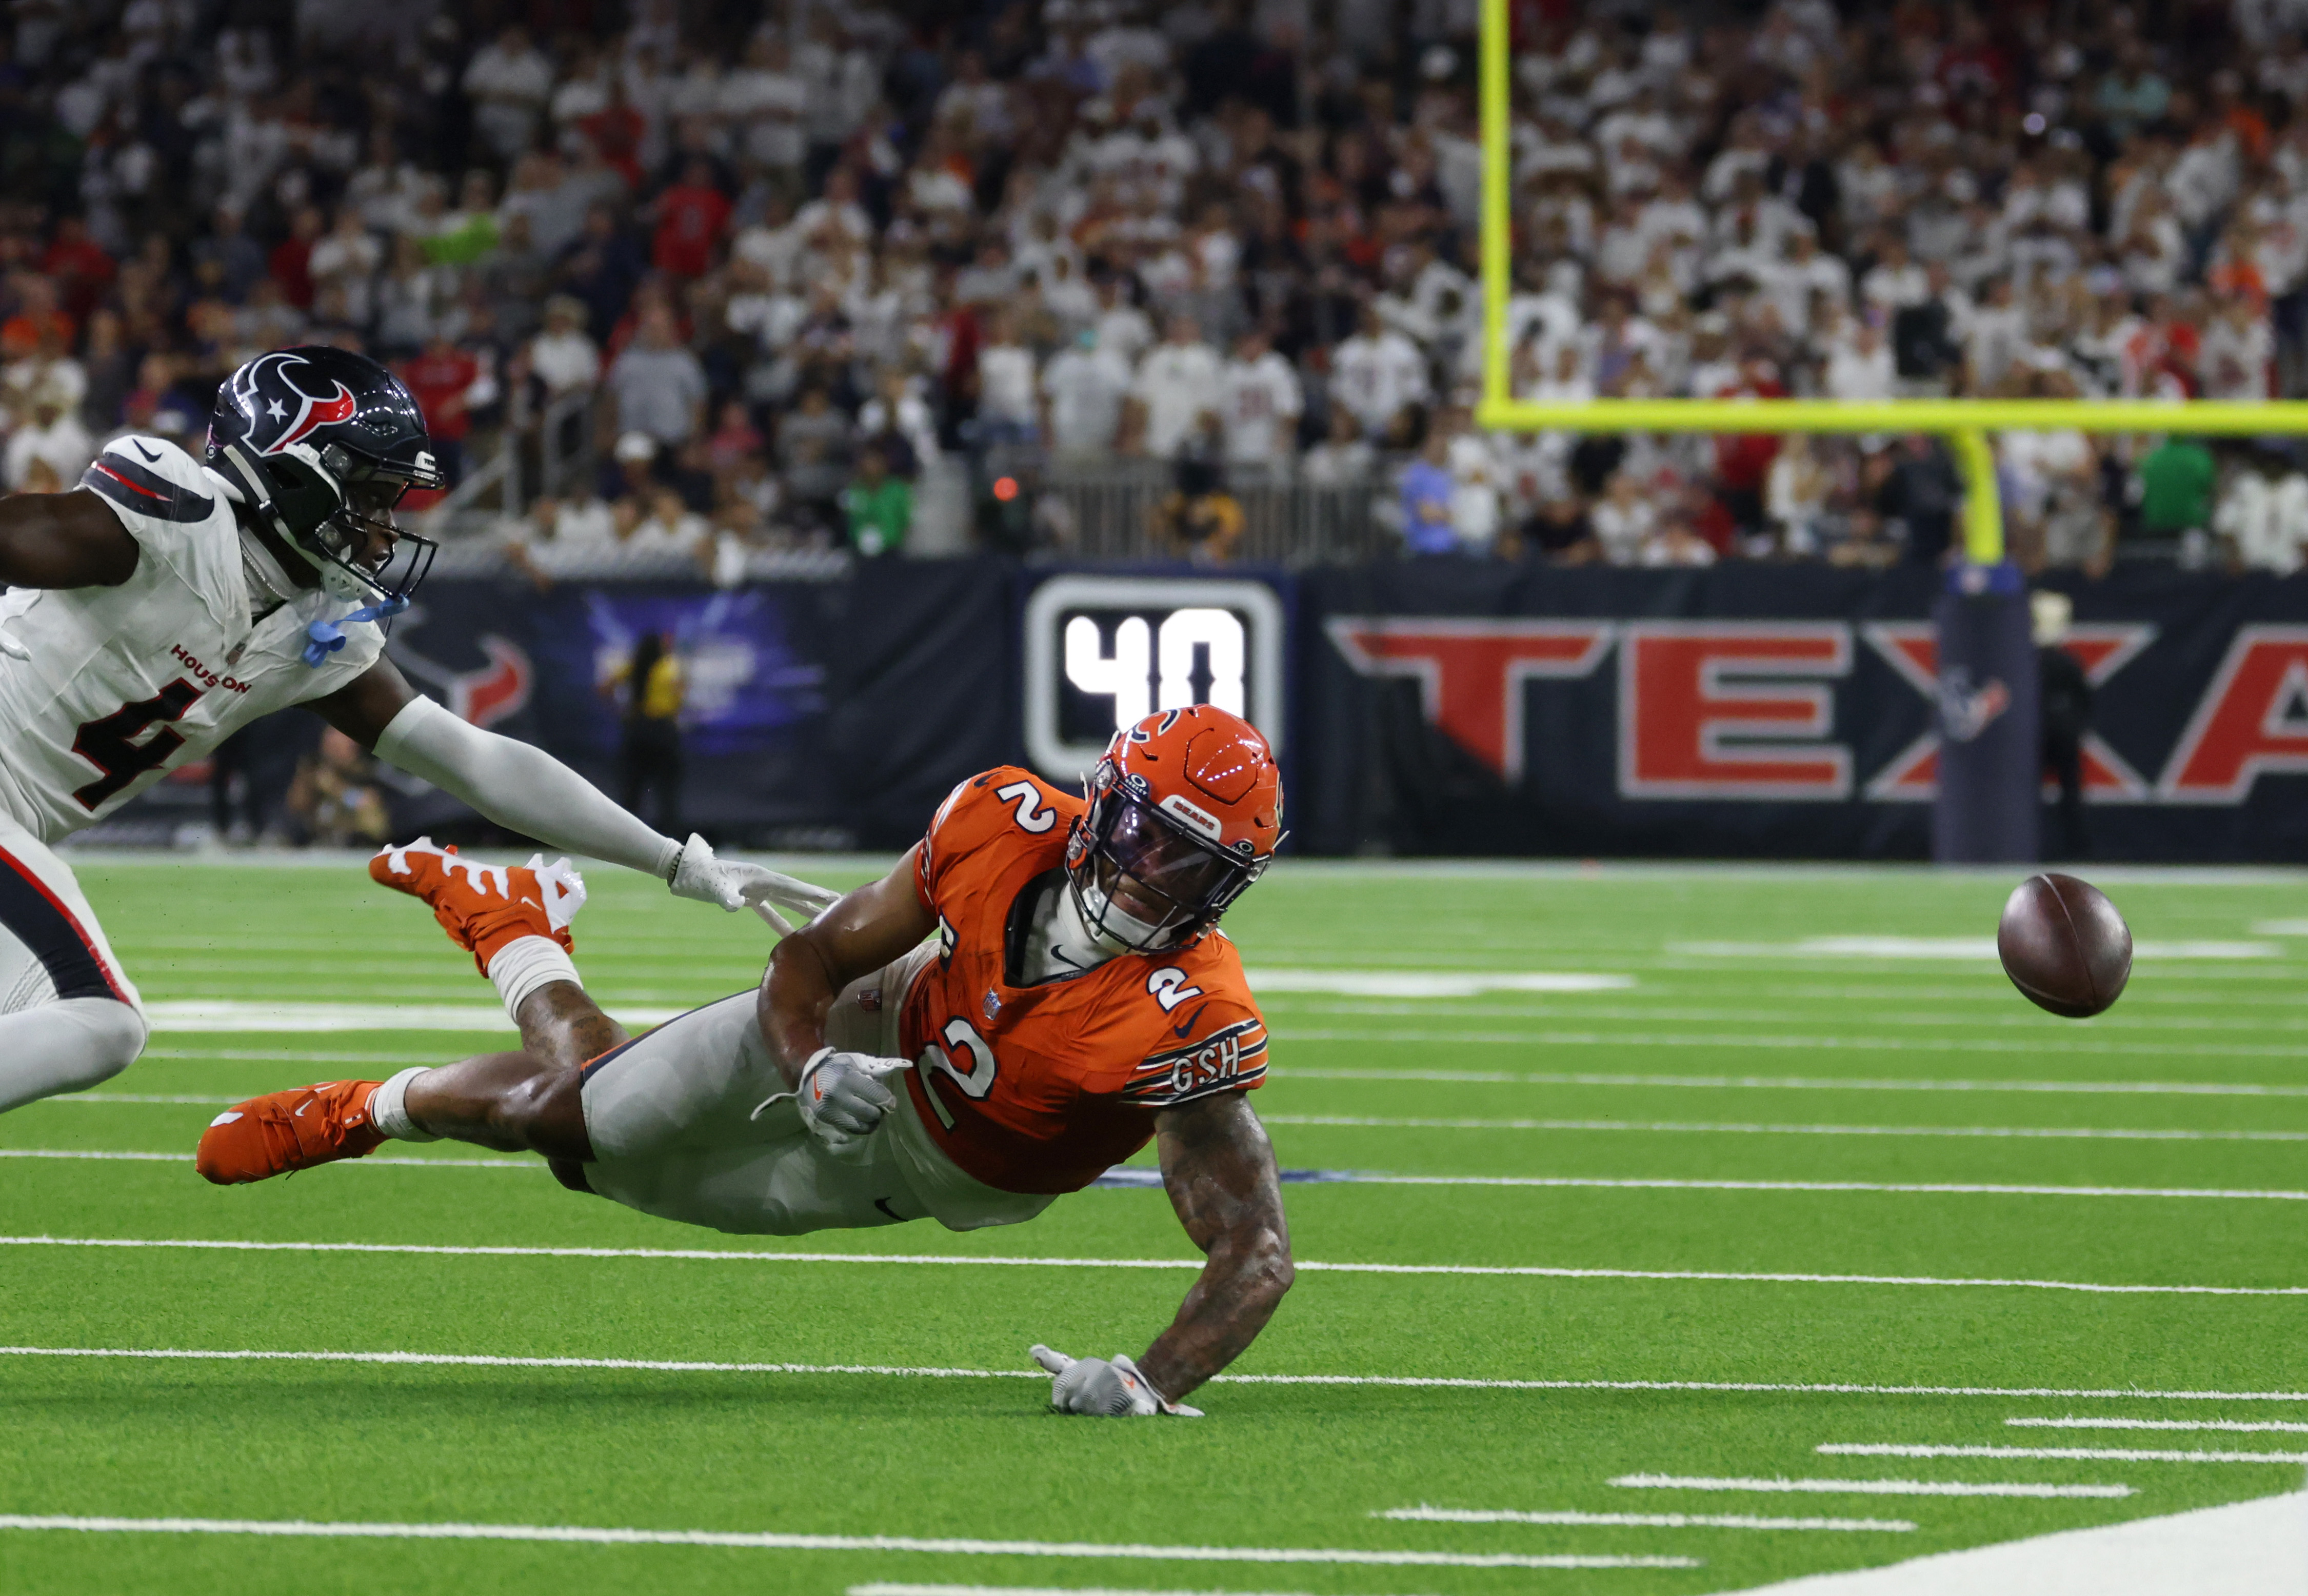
[{"xmin": 312, "ymin": 660, "xmax": 835, "ymax": 929}]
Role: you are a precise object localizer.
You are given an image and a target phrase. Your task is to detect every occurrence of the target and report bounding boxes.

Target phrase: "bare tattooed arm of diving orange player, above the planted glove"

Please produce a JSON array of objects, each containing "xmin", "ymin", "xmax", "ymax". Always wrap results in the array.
[{"xmin": 1138, "ymin": 1091, "xmax": 1292, "ymax": 1402}]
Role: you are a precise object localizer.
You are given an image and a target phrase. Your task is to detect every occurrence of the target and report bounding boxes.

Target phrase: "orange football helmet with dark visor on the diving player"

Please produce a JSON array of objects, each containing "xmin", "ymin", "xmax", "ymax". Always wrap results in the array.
[{"xmin": 1066, "ymin": 704, "xmax": 1286, "ymax": 952}]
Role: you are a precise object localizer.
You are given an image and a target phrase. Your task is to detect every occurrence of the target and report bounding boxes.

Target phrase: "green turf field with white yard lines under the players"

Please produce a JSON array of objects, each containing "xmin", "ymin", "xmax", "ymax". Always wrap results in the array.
[{"xmin": 0, "ymin": 860, "xmax": 2308, "ymax": 1596}]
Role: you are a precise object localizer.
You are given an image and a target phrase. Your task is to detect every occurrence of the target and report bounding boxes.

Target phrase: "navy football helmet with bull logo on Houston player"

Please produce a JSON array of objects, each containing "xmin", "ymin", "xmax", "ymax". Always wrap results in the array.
[{"xmin": 206, "ymin": 344, "xmax": 448, "ymax": 609}]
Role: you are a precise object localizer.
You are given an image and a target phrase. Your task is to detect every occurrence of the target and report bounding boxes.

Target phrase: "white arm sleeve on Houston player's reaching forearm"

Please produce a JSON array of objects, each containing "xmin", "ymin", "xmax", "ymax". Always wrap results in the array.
[{"xmin": 376, "ymin": 696, "xmax": 681, "ymax": 881}]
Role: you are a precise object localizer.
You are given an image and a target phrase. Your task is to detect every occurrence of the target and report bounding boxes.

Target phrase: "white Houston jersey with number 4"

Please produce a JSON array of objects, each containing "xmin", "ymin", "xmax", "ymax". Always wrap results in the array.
[{"xmin": 0, "ymin": 436, "xmax": 386, "ymax": 844}]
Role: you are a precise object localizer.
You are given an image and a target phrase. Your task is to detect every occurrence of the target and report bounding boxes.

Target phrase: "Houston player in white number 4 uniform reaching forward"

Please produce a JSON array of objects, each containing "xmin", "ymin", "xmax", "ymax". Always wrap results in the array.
[{"xmin": 0, "ymin": 348, "xmax": 831, "ymax": 1112}]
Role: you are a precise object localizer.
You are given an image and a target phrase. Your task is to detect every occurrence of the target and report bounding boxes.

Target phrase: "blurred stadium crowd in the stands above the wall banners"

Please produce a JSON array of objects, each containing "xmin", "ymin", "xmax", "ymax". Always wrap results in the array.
[{"xmin": 0, "ymin": 0, "xmax": 2308, "ymax": 574}]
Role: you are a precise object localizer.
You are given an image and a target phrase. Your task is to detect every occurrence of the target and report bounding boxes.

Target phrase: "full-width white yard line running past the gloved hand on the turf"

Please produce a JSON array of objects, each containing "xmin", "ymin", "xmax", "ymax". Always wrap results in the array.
[{"xmin": 13, "ymin": 1347, "xmax": 2308, "ymax": 1402}]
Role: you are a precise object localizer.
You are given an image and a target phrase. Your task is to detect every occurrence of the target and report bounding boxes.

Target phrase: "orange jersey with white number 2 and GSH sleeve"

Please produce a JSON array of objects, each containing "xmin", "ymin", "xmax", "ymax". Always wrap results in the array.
[{"xmin": 900, "ymin": 766, "xmax": 1267, "ymax": 1192}]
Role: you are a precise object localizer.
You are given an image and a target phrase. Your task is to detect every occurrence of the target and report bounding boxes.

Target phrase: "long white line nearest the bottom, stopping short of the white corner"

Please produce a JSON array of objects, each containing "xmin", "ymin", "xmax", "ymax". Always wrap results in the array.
[{"xmin": 0, "ymin": 1513, "xmax": 1703, "ymax": 1568}]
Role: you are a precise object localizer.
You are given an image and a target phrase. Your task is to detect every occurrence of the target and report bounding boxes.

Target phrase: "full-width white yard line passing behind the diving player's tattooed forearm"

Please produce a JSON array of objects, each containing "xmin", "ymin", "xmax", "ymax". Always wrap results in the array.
[{"xmin": 0, "ymin": 1236, "xmax": 2308, "ymax": 1296}]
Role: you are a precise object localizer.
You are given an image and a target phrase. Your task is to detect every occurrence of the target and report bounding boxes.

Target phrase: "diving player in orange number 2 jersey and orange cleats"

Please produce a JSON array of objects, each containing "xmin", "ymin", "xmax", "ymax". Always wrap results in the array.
[{"xmin": 198, "ymin": 706, "xmax": 1290, "ymax": 1414}]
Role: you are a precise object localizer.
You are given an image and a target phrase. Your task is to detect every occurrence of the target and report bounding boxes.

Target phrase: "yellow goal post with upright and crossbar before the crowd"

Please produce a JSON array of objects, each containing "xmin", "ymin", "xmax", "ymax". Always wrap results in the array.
[{"xmin": 1475, "ymin": 0, "xmax": 2308, "ymax": 563}]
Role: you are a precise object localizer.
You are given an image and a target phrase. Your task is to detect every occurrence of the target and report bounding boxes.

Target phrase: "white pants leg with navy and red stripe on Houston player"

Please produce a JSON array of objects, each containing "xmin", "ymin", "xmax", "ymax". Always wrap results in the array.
[{"xmin": 0, "ymin": 812, "xmax": 146, "ymax": 1114}]
